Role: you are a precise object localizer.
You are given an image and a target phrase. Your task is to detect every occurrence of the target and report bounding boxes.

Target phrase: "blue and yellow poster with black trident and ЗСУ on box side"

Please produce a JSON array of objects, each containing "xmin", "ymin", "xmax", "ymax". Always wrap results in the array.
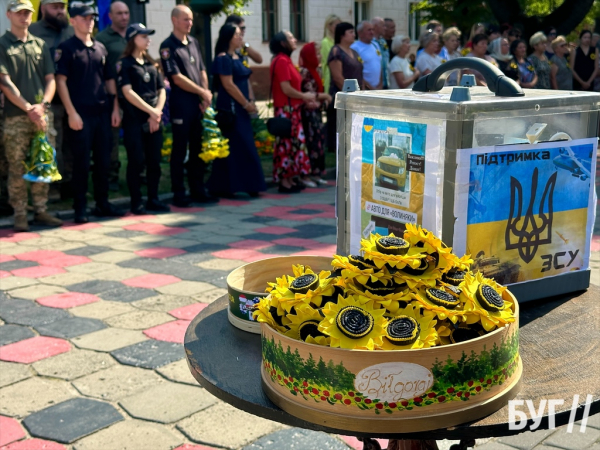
[{"xmin": 454, "ymin": 138, "xmax": 597, "ymax": 284}]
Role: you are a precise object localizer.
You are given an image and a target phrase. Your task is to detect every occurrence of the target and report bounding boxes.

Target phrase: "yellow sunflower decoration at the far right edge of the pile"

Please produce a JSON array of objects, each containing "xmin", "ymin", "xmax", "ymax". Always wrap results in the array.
[{"xmin": 459, "ymin": 272, "xmax": 515, "ymax": 332}]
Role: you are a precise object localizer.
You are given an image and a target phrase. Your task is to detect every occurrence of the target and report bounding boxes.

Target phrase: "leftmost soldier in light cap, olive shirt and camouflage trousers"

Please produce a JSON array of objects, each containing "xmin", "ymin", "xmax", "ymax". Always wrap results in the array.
[{"xmin": 0, "ymin": 0, "xmax": 62, "ymax": 231}]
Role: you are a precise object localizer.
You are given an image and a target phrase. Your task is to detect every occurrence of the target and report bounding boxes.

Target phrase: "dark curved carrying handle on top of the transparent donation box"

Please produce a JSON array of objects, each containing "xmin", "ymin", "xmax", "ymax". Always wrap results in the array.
[{"xmin": 413, "ymin": 58, "xmax": 525, "ymax": 97}]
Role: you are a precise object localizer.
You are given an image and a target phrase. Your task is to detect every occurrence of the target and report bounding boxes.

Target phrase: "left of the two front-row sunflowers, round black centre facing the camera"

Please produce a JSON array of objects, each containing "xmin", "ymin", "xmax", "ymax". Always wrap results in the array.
[{"xmin": 319, "ymin": 295, "xmax": 386, "ymax": 350}]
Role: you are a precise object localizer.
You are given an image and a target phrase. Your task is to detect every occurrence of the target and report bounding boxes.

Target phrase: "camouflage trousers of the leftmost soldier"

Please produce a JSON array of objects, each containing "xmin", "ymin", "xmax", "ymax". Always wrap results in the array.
[{"xmin": 4, "ymin": 111, "xmax": 55, "ymax": 216}]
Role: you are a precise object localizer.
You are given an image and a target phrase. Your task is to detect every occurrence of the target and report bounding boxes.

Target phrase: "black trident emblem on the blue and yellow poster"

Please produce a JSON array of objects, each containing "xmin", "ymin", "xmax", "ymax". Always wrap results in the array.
[{"xmin": 504, "ymin": 167, "xmax": 557, "ymax": 263}]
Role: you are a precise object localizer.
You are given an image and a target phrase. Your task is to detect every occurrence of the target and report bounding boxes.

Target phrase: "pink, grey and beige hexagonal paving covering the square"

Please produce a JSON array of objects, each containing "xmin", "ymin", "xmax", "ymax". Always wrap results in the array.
[{"xmin": 0, "ymin": 181, "xmax": 600, "ymax": 450}]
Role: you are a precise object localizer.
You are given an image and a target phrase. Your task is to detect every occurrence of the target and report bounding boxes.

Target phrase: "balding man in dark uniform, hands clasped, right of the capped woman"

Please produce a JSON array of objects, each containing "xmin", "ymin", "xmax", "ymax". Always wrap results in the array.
[{"xmin": 160, "ymin": 5, "xmax": 218, "ymax": 207}]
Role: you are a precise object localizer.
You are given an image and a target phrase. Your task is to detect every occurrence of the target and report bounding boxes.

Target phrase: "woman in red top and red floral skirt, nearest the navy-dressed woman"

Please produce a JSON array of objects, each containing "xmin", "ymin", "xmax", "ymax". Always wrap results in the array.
[{"xmin": 269, "ymin": 31, "xmax": 316, "ymax": 194}]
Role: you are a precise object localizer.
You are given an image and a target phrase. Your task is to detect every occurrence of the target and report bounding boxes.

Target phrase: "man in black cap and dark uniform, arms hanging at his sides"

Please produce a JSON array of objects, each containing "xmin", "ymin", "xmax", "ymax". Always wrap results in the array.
[{"xmin": 54, "ymin": 2, "xmax": 123, "ymax": 223}]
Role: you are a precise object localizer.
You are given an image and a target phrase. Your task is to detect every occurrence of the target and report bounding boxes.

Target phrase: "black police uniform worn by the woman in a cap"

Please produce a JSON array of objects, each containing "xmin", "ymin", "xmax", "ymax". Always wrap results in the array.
[{"xmin": 117, "ymin": 56, "xmax": 165, "ymax": 211}]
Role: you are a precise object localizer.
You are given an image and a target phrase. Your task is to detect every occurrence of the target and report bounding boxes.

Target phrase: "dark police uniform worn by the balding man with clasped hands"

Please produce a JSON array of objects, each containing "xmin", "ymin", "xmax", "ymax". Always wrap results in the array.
[{"xmin": 160, "ymin": 33, "xmax": 208, "ymax": 201}]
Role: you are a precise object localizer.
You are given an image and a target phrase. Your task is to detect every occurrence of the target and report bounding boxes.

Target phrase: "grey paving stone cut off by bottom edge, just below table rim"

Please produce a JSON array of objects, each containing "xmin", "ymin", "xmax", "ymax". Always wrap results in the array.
[{"xmin": 242, "ymin": 428, "xmax": 348, "ymax": 450}]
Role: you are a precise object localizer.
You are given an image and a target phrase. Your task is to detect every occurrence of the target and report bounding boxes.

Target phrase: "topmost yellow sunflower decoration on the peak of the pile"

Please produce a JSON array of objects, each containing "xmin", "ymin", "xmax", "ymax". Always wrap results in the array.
[{"xmin": 360, "ymin": 233, "xmax": 425, "ymax": 269}]
